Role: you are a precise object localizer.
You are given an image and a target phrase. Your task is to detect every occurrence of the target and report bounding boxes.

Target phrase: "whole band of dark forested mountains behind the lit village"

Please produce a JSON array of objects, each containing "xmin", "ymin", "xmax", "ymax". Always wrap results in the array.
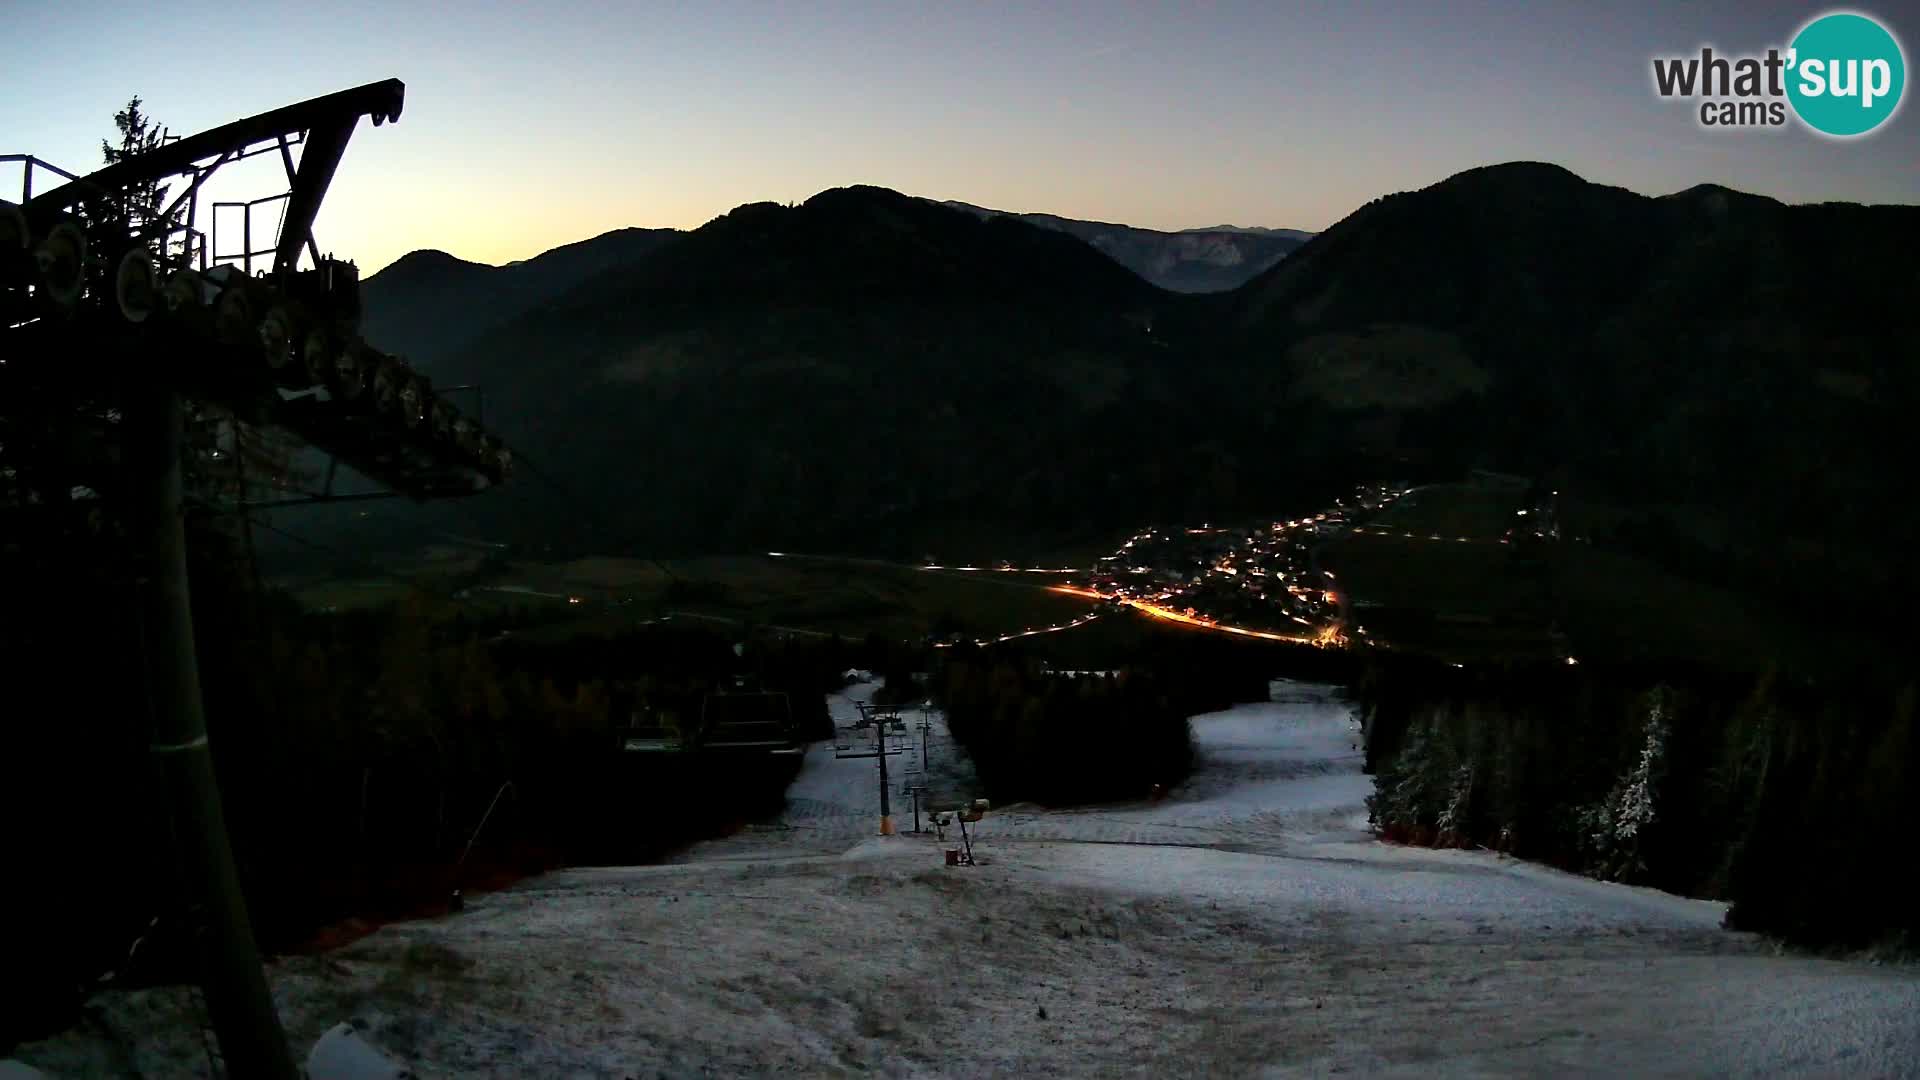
[{"xmin": 274, "ymin": 163, "xmax": 1920, "ymax": 607}]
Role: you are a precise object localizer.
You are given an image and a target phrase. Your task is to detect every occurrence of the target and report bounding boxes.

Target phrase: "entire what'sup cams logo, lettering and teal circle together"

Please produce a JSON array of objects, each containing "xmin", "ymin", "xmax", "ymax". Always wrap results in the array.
[{"xmin": 1653, "ymin": 12, "xmax": 1907, "ymax": 138}]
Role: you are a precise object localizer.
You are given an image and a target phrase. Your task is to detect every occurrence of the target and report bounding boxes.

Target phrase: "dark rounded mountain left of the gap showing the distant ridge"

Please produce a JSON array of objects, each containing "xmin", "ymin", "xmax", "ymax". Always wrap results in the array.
[{"xmin": 284, "ymin": 180, "xmax": 1259, "ymax": 553}]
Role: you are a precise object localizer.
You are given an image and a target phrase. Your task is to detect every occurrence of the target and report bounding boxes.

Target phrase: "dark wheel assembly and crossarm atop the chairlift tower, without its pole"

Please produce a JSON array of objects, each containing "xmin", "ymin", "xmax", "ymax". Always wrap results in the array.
[{"xmin": 0, "ymin": 79, "xmax": 513, "ymax": 500}]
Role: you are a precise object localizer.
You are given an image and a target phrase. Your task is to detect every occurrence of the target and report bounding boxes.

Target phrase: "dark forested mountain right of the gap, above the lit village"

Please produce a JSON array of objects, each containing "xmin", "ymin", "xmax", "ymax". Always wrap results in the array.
[{"xmin": 1235, "ymin": 163, "xmax": 1920, "ymax": 591}]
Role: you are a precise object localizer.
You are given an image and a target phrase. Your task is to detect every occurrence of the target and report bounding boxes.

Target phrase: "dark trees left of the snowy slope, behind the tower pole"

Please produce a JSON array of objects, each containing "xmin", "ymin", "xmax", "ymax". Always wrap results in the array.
[{"xmin": 0, "ymin": 515, "xmax": 862, "ymax": 1045}]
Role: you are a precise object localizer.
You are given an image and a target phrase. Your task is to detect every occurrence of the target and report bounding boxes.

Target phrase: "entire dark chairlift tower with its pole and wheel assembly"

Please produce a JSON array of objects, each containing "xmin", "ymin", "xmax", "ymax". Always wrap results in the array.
[{"xmin": 0, "ymin": 79, "xmax": 511, "ymax": 1080}]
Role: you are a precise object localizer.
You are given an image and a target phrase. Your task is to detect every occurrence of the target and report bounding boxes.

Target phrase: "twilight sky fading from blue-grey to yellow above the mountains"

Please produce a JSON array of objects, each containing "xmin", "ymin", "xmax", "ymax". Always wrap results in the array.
[{"xmin": 0, "ymin": 0, "xmax": 1920, "ymax": 271}]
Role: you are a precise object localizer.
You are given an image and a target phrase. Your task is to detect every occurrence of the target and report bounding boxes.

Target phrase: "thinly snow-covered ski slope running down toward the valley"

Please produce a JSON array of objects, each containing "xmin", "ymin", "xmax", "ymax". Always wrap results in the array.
[{"xmin": 19, "ymin": 672, "xmax": 1920, "ymax": 1076}]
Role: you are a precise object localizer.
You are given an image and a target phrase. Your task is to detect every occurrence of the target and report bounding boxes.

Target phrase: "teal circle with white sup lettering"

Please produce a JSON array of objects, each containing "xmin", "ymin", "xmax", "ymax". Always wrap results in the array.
[{"xmin": 1788, "ymin": 12, "xmax": 1907, "ymax": 138}]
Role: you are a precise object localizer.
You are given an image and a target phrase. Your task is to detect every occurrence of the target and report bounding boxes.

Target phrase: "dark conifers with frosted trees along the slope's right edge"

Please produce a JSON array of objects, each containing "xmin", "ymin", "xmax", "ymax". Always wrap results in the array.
[{"xmin": 1356, "ymin": 655, "xmax": 1920, "ymax": 947}]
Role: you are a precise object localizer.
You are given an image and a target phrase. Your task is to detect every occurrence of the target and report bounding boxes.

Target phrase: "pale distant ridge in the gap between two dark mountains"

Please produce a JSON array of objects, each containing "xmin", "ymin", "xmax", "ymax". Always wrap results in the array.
[{"xmin": 941, "ymin": 202, "xmax": 1313, "ymax": 292}]
